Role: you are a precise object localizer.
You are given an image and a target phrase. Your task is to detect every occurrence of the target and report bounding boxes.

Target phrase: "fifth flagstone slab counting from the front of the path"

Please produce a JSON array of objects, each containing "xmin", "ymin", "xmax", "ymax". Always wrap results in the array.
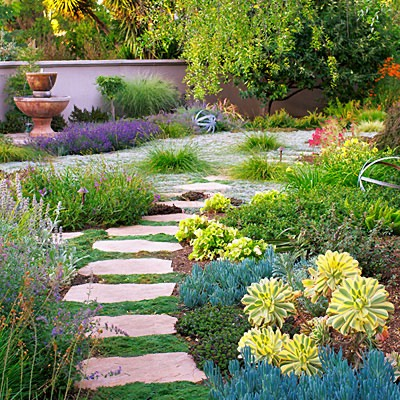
[{"xmin": 93, "ymin": 240, "xmax": 182, "ymax": 253}]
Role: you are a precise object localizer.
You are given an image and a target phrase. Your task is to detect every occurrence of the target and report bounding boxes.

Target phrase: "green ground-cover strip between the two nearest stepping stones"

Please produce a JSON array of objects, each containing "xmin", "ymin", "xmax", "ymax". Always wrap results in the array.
[{"xmin": 96, "ymin": 335, "xmax": 189, "ymax": 357}]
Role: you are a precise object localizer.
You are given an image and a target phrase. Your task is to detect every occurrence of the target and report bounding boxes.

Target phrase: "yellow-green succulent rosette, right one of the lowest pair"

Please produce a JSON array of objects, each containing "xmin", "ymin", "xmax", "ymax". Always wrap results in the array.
[{"xmin": 280, "ymin": 334, "xmax": 322, "ymax": 375}]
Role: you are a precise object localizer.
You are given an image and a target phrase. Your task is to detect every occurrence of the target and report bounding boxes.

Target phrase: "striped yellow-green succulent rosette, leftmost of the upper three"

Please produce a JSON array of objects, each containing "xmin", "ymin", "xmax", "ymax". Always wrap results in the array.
[{"xmin": 242, "ymin": 278, "xmax": 296, "ymax": 328}]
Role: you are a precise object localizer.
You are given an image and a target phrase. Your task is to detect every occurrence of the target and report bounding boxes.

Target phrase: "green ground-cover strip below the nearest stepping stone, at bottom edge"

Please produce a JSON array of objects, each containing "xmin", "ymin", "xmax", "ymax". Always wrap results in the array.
[{"xmin": 88, "ymin": 382, "xmax": 210, "ymax": 400}]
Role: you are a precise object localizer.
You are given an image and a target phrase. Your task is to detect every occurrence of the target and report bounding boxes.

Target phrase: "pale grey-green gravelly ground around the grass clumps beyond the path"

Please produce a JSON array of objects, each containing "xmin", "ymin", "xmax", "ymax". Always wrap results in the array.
[{"xmin": 0, "ymin": 131, "xmax": 313, "ymax": 201}]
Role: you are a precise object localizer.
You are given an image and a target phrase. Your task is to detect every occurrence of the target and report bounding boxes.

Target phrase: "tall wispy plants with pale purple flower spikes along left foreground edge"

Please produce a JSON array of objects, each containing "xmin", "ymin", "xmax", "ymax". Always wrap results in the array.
[{"xmin": 0, "ymin": 180, "xmax": 94, "ymax": 400}]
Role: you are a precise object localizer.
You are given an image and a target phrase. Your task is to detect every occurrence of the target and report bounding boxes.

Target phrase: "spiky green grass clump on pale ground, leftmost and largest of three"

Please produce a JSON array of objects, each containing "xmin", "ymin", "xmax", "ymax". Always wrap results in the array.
[{"xmin": 143, "ymin": 144, "xmax": 211, "ymax": 174}]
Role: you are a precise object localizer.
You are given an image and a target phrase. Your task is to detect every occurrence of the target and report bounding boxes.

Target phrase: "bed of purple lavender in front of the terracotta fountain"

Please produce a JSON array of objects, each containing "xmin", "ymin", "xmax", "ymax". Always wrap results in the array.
[{"xmin": 36, "ymin": 120, "xmax": 159, "ymax": 156}]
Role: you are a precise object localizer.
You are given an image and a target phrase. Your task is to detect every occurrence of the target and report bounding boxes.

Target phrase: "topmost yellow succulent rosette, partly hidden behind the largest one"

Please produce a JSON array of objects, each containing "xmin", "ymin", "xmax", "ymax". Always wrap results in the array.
[{"xmin": 303, "ymin": 250, "xmax": 361, "ymax": 303}]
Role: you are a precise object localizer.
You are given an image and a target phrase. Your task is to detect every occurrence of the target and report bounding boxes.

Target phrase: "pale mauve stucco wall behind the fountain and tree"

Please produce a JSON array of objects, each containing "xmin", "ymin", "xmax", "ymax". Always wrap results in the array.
[{"xmin": 0, "ymin": 60, "xmax": 321, "ymax": 119}]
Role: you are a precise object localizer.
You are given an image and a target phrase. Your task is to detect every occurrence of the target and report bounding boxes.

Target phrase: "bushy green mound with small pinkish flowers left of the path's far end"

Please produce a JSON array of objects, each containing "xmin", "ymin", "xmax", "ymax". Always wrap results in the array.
[{"xmin": 17, "ymin": 162, "xmax": 154, "ymax": 230}]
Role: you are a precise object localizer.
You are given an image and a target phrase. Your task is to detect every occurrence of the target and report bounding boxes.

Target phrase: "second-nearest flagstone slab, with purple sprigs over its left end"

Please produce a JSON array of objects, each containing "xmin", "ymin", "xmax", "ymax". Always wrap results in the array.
[{"xmin": 94, "ymin": 315, "xmax": 178, "ymax": 338}]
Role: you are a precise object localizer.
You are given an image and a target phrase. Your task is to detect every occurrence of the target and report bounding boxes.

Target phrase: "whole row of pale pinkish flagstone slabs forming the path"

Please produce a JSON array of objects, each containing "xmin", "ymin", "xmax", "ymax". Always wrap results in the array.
[{"xmin": 64, "ymin": 212, "xmax": 206, "ymax": 390}]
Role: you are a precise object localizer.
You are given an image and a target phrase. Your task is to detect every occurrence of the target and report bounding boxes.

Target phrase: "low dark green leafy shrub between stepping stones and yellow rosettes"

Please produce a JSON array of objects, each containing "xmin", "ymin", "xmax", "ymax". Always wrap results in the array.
[{"xmin": 176, "ymin": 305, "xmax": 250, "ymax": 370}]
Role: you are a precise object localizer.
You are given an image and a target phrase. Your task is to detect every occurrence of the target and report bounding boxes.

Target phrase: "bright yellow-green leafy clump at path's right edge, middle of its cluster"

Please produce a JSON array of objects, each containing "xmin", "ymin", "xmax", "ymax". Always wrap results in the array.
[{"xmin": 189, "ymin": 221, "xmax": 239, "ymax": 261}]
